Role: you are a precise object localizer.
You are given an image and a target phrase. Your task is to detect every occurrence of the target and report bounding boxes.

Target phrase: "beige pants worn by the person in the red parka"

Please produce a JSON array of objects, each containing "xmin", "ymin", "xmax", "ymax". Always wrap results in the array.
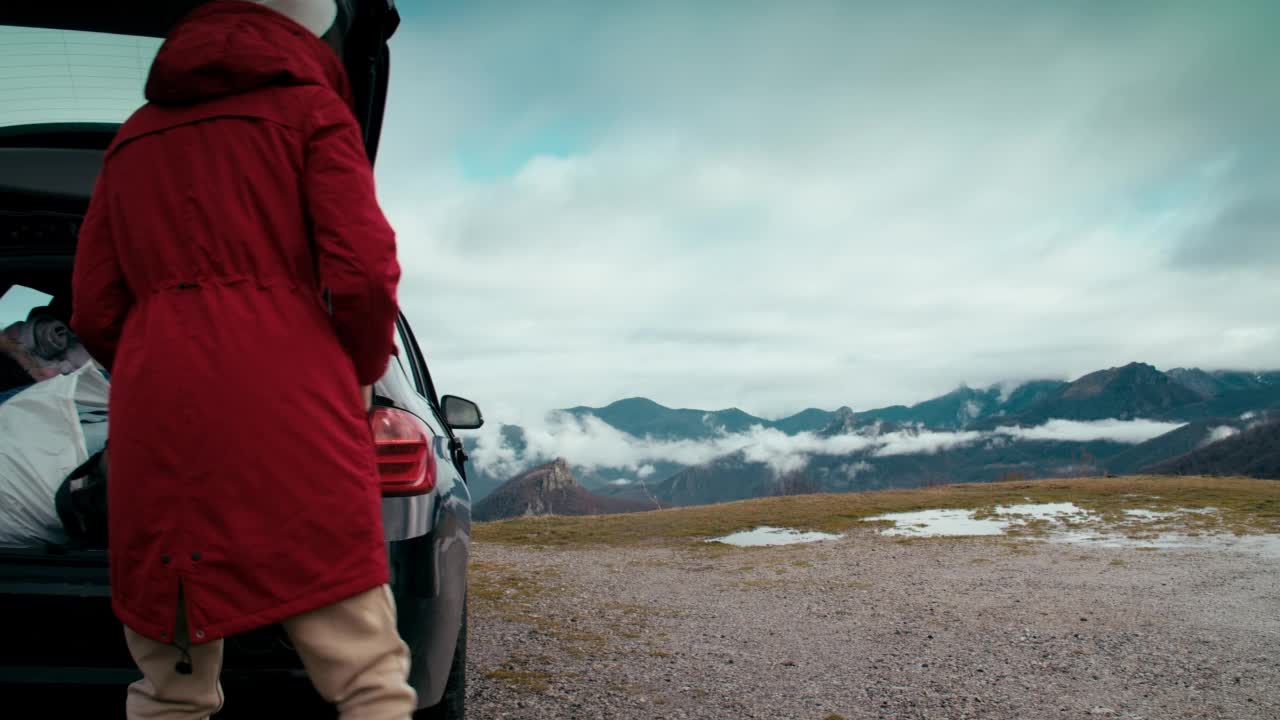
[{"xmin": 124, "ymin": 585, "xmax": 417, "ymax": 720}]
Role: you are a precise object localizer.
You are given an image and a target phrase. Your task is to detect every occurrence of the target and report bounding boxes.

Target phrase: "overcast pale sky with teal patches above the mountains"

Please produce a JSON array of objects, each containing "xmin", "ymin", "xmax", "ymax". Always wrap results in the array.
[{"xmin": 378, "ymin": 0, "xmax": 1280, "ymax": 419}]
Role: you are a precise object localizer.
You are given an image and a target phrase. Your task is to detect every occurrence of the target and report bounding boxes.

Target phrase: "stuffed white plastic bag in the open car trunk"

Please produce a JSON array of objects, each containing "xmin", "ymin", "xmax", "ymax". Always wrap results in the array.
[{"xmin": 0, "ymin": 363, "xmax": 110, "ymax": 547}]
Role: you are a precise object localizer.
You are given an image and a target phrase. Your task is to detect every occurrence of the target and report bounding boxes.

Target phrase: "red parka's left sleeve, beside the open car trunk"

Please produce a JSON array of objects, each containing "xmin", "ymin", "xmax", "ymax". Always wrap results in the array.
[{"xmin": 72, "ymin": 168, "xmax": 133, "ymax": 372}]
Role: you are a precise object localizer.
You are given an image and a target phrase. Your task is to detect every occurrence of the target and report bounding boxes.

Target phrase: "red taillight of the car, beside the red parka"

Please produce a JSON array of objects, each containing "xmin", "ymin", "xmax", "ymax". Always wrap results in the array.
[{"xmin": 369, "ymin": 407, "xmax": 435, "ymax": 495}]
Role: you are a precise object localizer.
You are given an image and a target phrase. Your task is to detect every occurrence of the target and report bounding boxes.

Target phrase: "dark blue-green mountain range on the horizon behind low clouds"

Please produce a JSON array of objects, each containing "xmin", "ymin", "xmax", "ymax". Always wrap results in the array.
[{"xmin": 471, "ymin": 363, "xmax": 1280, "ymax": 507}]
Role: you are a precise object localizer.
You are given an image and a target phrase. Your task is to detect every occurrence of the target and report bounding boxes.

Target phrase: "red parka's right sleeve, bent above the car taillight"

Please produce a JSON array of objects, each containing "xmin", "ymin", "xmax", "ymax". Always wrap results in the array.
[{"xmin": 303, "ymin": 97, "xmax": 401, "ymax": 384}]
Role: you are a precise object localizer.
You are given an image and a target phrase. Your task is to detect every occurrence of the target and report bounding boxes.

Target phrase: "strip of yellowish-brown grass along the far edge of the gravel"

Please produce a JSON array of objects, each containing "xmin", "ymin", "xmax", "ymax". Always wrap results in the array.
[{"xmin": 472, "ymin": 475, "xmax": 1280, "ymax": 545}]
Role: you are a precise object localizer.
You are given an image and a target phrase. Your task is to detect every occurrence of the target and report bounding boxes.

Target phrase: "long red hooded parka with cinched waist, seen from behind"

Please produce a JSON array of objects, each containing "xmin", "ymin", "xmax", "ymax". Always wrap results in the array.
[{"xmin": 72, "ymin": 1, "xmax": 399, "ymax": 644}]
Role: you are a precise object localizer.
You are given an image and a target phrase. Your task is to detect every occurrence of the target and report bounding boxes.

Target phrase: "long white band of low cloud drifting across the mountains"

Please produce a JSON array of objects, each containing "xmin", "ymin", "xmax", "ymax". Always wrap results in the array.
[{"xmin": 472, "ymin": 413, "xmax": 1181, "ymax": 479}]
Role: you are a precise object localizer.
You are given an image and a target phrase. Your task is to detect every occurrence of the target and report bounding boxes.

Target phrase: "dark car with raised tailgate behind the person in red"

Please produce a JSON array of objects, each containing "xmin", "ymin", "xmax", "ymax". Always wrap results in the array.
[{"xmin": 0, "ymin": 0, "xmax": 483, "ymax": 719}]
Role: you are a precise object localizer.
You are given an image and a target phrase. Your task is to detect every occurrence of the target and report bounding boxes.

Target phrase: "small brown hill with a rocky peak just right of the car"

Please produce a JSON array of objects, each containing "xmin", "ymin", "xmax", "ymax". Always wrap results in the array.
[{"xmin": 471, "ymin": 460, "xmax": 654, "ymax": 520}]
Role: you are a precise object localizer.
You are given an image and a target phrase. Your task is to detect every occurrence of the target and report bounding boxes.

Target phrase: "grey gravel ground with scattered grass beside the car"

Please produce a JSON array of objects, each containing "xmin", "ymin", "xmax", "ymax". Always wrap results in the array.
[{"xmin": 467, "ymin": 529, "xmax": 1280, "ymax": 720}]
